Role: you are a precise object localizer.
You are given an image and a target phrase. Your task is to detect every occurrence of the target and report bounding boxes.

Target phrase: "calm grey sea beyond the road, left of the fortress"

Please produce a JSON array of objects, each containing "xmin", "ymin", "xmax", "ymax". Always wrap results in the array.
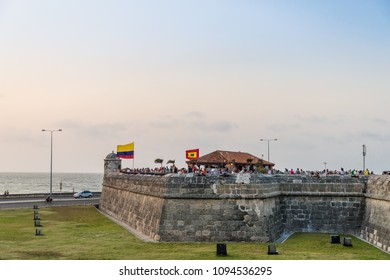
[{"xmin": 0, "ymin": 172, "xmax": 103, "ymax": 194}]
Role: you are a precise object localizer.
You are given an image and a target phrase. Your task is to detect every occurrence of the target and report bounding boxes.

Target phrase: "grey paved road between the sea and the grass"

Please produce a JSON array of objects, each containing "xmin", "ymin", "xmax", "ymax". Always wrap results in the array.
[{"xmin": 0, "ymin": 193, "xmax": 100, "ymax": 210}]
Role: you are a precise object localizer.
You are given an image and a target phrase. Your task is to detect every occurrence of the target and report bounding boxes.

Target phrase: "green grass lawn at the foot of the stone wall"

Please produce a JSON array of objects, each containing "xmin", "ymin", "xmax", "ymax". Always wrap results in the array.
[{"xmin": 0, "ymin": 206, "xmax": 390, "ymax": 260}]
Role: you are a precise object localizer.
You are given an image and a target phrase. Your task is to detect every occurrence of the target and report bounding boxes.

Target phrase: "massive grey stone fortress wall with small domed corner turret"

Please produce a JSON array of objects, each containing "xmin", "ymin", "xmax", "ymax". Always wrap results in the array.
[{"xmin": 99, "ymin": 152, "xmax": 390, "ymax": 253}]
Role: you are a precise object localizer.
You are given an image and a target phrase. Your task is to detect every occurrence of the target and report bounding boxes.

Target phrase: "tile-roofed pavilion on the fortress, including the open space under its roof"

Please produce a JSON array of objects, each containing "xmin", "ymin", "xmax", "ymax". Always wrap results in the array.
[{"xmin": 187, "ymin": 150, "xmax": 275, "ymax": 170}]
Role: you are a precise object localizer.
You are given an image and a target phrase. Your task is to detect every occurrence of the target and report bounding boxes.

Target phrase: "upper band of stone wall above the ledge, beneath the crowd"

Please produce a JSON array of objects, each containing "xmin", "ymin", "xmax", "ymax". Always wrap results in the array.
[{"xmin": 103, "ymin": 172, "xmax": 366, "ymax": 199}]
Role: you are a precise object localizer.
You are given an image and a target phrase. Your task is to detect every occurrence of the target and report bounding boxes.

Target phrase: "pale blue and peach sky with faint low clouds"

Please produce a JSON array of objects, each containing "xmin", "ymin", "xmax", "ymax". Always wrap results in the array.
[{"xmin": 0, "ymin": 0, "xmax": 390, "ymax": 173}]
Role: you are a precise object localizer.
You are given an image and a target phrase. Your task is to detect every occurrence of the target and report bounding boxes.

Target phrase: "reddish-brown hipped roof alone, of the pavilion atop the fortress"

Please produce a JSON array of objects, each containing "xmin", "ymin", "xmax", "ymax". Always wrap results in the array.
[{"xmin": 187, "ymin": 150, "xmax": 275, "ymax": 169}]
